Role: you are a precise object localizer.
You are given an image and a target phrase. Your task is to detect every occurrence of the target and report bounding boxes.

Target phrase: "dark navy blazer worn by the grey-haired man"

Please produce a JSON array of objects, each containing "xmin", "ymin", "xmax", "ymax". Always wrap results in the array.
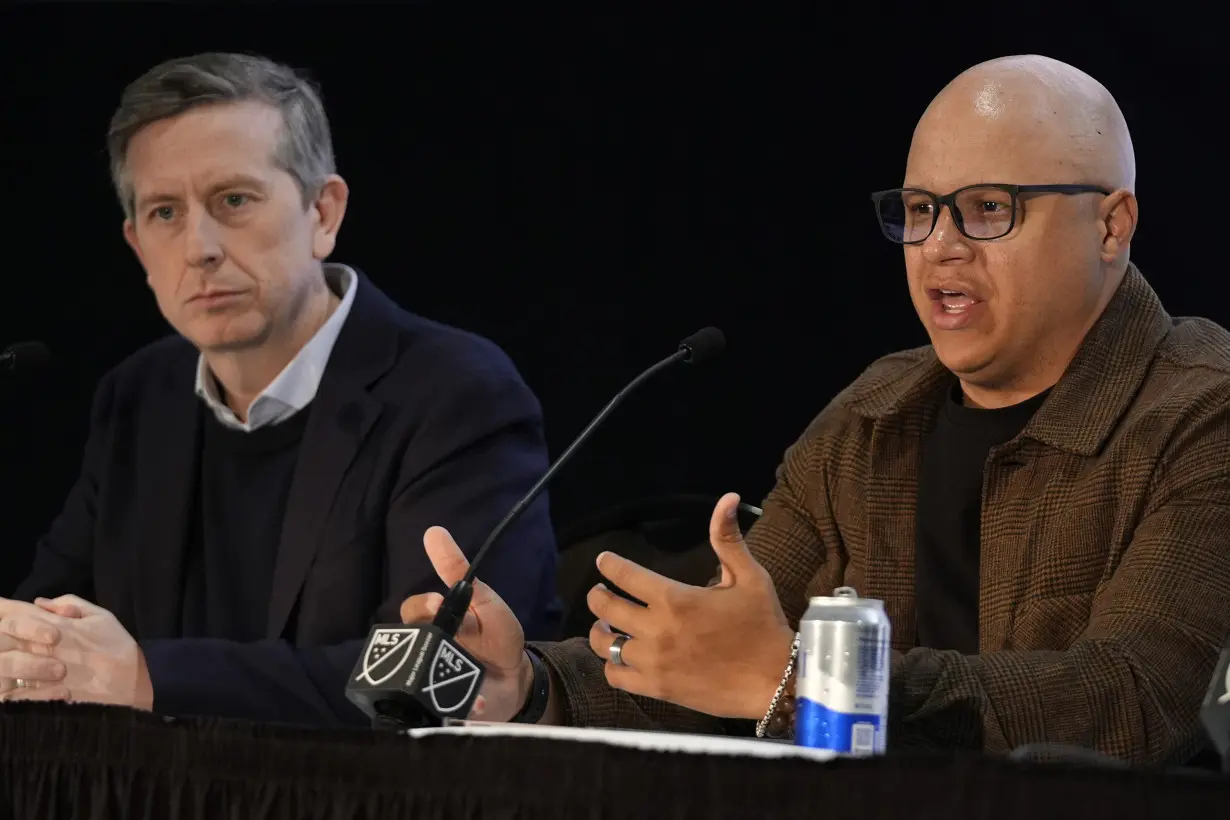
[{"xmin": 15, "ymin": 274, "xmax": 557, "ymax": 725}]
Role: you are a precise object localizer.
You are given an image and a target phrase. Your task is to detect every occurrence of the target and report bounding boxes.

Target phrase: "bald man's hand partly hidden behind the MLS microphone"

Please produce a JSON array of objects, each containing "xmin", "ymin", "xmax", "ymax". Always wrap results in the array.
[{"xmin": 401, "ymin": 526, "xmax": 534, "ymax": 723}]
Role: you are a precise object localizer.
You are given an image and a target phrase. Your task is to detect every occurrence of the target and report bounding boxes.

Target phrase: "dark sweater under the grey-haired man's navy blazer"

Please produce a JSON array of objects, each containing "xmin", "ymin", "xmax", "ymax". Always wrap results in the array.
[{"xmin": 182, "ymin": 407, "xmax": 311, "ymax": 642}]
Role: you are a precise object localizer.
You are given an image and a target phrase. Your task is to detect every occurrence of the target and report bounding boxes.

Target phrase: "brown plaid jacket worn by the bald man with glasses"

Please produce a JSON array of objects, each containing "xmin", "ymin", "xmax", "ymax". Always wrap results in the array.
[{"xmin": 538, "ymin": 267, "xmax": 1230, "ymax": 763}]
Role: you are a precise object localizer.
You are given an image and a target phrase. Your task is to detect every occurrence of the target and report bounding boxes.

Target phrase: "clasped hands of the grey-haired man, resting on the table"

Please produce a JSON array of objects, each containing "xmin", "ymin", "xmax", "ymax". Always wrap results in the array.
[{"xmin": 0, "ymin": 595, "xmax": 154, "ymax": 709}]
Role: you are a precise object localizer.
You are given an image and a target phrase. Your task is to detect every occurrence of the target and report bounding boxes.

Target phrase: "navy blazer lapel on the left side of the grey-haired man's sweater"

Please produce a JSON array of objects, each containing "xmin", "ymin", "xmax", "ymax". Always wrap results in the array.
[{"xmin": 133, "ymin": 366, "xmax": 203, "ymax": 639}]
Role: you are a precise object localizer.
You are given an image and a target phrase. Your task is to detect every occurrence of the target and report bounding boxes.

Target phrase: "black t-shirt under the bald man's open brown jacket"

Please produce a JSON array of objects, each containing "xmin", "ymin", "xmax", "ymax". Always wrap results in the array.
[{"xmin": 914, "ymin": 384, "xmax": 1047, "ymax": 654}]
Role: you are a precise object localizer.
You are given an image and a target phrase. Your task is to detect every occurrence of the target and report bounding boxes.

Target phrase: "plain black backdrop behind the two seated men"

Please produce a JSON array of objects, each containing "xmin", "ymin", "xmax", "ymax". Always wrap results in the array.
[{"xmin": 0, "ymin": 2, "xmax": 1230, "ymax": 593}]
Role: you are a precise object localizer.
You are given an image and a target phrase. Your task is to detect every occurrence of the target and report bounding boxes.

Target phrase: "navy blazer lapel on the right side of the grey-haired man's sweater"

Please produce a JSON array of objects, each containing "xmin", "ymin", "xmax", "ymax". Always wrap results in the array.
[{"xmin": 266, "ymin": 272, "xmax": 397, "ymax": 639}]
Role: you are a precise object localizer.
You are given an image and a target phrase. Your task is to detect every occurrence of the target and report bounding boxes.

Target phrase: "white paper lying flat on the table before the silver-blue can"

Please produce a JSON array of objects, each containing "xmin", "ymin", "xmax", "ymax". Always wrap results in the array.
[{"xmin": 407, "ymin": 720, "xmax": 836, "ymax": 761}]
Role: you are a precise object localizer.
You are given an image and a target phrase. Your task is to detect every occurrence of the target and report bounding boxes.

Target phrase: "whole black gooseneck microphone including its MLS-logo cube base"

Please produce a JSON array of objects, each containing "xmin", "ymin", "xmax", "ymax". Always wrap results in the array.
[{"xmin": 346, "ymin": 327, "xmax": 726, "ymax": 729}]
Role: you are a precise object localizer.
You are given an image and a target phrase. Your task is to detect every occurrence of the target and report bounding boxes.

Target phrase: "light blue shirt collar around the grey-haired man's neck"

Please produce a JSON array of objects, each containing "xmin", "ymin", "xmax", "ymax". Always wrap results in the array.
[{"xmin": 197, "ymin": 264, "xmax": 359, "ymax": 433}]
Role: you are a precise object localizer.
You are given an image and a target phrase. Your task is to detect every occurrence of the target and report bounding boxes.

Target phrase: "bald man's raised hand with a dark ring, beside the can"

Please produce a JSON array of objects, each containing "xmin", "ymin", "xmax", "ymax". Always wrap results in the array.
[{"xmin": 588, "ymin": 493, "xmax": 795, "ymax": 719}]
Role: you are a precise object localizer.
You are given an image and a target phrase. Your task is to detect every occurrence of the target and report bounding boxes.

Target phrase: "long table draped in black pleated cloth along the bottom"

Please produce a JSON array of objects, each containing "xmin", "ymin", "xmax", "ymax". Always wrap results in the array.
[{"xmin": 0, "ymin": 703, "xmax": 1230, "ymax": 820}]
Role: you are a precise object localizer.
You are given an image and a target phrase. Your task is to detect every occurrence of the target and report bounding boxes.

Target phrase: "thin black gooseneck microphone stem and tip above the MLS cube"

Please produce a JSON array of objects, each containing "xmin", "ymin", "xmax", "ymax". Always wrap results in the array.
[{"xmin": 432, "ymin": 327, "xmax": 726, "ymax": 636}]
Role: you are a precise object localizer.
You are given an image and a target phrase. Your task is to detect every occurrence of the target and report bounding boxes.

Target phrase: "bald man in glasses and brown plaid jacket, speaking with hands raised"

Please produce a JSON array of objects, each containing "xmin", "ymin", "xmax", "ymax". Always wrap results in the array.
[{"xmin": 402, "ymin": 57, "xmax": 1230, "ymax": 763}]
